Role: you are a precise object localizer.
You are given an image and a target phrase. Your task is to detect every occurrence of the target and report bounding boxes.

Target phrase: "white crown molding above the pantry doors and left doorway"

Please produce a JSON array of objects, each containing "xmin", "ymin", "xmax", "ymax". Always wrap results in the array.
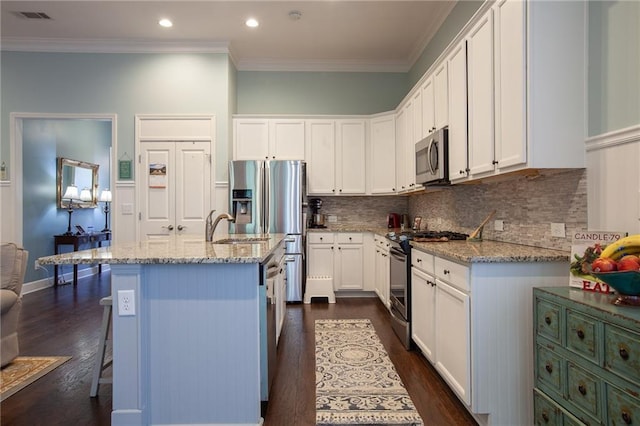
[{"xmin": 0, "ymin": 37, "xmax": 229, "ymax": 53}]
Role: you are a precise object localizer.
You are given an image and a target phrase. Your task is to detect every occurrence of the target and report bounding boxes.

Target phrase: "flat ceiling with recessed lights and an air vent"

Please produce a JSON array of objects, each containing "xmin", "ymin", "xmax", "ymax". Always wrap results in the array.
[{"xmin": 0, "ymin": 0, "xmax": 456, "ymax": 72}]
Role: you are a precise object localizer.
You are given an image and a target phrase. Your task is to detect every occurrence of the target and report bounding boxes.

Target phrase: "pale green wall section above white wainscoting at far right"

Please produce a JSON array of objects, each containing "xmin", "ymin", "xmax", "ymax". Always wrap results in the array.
[{"xmin": 588, "ymin": 1, "xmax": 640, "ymax": 136}]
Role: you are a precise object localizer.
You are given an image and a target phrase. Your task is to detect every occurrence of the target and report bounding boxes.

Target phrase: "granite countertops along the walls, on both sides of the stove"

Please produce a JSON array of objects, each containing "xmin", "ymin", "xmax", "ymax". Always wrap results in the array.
[{"xmin": 308, "ymin": 224, "xmax": 571, "ymax": 262}]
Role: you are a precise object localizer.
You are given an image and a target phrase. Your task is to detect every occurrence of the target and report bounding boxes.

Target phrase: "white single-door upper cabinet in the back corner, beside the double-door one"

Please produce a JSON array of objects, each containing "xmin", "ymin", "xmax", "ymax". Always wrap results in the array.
[{"xmin": 369, "ymin": 113, "xmax": 396, "ymax": 194}]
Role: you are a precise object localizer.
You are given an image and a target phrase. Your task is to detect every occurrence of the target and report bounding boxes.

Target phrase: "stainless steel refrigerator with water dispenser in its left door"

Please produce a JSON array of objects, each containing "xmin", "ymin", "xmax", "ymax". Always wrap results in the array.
[{"xmin": 229, "ymin": 160, "xmax": 307, "ymax": 302}]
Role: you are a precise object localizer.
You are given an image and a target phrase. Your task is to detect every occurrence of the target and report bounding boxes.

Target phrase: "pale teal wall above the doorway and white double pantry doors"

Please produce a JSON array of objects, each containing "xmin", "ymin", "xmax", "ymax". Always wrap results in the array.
[{"xmin": 0, "ymin": 52, "xmax": 231, "ymax": 180}]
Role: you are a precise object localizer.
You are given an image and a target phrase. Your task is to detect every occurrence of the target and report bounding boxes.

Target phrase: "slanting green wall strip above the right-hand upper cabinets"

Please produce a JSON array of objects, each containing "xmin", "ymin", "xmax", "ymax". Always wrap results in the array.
[{"xmin": 408, "ymin": 0, "xmax": 484, "ymax": 88}]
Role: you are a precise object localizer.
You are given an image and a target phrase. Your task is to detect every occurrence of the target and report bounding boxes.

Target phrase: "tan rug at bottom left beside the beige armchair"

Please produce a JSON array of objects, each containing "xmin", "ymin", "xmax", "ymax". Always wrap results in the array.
[{"xmin": 0, "ymin": 356, "xmax": 71, "ymax": 401}]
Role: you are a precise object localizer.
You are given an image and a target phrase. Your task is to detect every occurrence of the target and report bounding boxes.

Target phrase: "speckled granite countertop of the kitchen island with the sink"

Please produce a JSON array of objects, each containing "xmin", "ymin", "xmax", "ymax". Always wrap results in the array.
[{"xmin": 36, "ymin": 234, "xmax": 286, "ymax": 265}]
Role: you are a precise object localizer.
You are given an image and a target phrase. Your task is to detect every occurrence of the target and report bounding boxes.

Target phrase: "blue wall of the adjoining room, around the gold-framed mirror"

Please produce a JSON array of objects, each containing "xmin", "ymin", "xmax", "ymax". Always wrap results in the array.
[{"xmin": 22, "ymin": 119, "xmax": 111, "ymax": 282}]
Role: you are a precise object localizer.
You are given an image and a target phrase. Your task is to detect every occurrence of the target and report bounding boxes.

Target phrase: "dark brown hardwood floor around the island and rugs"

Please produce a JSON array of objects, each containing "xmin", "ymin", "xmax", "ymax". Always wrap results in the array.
[{"xmin": 0, "ymin": 272, "xmax": 475, "ymax": 426}]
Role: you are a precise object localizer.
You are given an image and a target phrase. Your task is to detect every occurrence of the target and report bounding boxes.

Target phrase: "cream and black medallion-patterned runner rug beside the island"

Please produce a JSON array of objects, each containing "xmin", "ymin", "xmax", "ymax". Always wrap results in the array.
[{"xmin": 315, "ymin": 319, "xmax": 423, "ymax": 426}]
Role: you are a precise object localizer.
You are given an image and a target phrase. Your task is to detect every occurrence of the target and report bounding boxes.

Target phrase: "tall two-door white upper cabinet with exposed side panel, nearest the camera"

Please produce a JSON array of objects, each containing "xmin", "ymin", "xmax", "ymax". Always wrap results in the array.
[{"xmin": 466, "ymin": 0, "xmax": 586, "ymax": 179}]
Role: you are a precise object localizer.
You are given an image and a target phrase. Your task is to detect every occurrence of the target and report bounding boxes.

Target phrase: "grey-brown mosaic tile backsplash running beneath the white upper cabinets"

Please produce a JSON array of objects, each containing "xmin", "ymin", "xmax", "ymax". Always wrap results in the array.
[{"xmin": 320, "ymin": 169, "xmax": 587, "ymax": 251}]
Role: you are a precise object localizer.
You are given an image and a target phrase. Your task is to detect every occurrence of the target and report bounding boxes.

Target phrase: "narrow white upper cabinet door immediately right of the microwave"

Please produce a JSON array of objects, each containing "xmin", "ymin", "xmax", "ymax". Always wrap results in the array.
[{"xmin": 447, "ymin": 40, "xmax": 468, "ymax": 182}]
